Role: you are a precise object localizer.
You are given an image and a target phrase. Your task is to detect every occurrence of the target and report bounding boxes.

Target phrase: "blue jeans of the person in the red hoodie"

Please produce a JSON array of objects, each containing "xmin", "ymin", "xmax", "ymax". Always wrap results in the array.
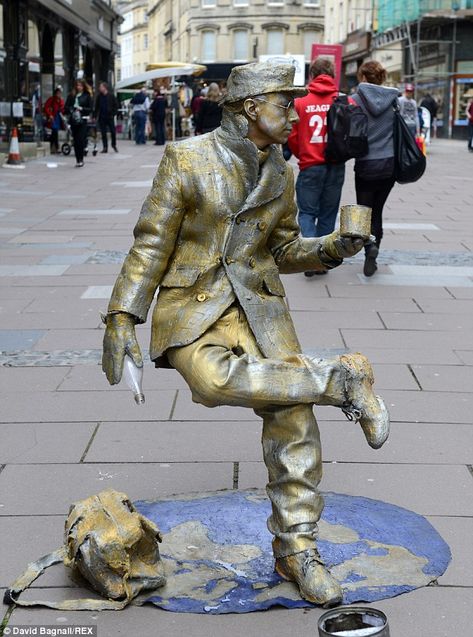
[{"xmin": 296, "ymin": 164, "xmax": 345, "ymax": 237}]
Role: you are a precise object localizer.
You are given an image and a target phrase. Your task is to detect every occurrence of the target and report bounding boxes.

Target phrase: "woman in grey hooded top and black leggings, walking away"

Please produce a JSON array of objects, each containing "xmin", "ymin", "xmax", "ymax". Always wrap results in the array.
[{"xmin": 353, "ymin": 60, "xmax": 398, "ymax": 276}]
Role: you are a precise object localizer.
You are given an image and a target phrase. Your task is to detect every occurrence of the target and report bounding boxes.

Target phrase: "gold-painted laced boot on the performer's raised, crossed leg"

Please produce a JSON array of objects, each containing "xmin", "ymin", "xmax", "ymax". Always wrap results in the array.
[{"xmin": 340, "ymin": 354, "xmax": 389, "ymax": 449}]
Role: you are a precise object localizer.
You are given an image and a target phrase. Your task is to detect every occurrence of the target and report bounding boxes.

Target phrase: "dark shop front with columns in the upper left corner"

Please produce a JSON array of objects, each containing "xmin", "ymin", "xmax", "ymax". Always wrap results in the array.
[{"xmin": 0, "ymin": 0, "xmax": 120, "ymax": 142}]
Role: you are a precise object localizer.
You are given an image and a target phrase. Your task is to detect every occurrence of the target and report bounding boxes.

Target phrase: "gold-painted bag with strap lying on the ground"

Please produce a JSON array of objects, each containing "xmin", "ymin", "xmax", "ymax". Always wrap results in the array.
[{"xmin": 4, "ymin": 489, "xmax": 166, "ymax": 610}]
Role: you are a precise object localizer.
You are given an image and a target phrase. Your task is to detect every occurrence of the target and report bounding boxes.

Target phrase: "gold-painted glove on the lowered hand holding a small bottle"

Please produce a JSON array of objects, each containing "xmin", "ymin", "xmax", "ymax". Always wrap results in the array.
[{"xmin": 102, "ymin": 312, "xmax": 143, "ymax": 385}]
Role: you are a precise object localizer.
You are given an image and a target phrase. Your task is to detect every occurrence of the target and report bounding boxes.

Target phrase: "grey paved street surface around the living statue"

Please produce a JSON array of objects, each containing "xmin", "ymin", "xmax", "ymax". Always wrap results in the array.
[{"xmin": 0, "ymin": 141, "xmax": 473, "ymax": 637}]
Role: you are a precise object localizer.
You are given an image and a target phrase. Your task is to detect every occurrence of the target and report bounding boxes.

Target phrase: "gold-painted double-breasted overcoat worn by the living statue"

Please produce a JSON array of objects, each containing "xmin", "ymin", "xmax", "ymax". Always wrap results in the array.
[{"xmin": 108, "ymin": 114, "xmax": 341, "ymax": 366}]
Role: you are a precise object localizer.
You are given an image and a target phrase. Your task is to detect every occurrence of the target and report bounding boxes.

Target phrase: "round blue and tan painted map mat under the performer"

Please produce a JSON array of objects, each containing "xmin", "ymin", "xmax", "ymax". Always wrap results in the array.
[{"xmin": 135, "ymin": 490, "xmax": 451, "ymax": 614}]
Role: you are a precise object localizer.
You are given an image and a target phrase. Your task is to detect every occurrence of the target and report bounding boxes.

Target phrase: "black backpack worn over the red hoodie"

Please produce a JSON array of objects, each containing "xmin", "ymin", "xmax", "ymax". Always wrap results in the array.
[{"xmin": 325, "ymin": 95, "xmax": 368, "ymax": 164}]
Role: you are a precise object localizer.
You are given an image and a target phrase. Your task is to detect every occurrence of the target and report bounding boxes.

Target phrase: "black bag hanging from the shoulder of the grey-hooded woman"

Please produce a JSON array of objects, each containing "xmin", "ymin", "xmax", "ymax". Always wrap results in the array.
[{"xmin": 393, "ymin": 100, "xmax": 427, "ymax": 184}]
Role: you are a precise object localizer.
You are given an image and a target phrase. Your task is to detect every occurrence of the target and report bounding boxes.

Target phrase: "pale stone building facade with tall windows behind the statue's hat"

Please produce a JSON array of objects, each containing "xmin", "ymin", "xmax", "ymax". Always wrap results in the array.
[{"xmin": 148, "ymin": 0, "xmax": 324, "ymax": 79}]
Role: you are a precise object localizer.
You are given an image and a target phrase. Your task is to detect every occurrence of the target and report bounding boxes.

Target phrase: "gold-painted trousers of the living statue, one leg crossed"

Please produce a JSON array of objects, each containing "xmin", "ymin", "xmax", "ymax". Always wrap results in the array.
[{"xmin": 167, "ymin": 305, "xmax": 346, "ymax": 557}]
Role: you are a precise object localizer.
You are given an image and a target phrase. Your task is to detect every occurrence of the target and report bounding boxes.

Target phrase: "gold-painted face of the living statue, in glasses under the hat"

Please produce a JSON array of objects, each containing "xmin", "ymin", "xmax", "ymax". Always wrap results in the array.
[{"xmin": 251, "ymin": 93, "xmax": 299, "ymax": 144}]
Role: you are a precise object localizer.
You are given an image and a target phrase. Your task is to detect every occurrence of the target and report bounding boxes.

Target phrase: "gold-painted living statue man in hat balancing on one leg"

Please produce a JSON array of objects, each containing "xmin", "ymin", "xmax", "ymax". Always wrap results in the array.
[{"xmin": 103, "ymin": 64, "xmax": 389, "ymax": 605}]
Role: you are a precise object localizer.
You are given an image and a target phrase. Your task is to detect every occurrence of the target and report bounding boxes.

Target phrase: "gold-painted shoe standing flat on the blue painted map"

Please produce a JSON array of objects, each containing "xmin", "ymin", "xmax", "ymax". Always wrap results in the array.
[{"xmin": 275, "ymin": 548, "xmax": 343, "ymax": 607}]
